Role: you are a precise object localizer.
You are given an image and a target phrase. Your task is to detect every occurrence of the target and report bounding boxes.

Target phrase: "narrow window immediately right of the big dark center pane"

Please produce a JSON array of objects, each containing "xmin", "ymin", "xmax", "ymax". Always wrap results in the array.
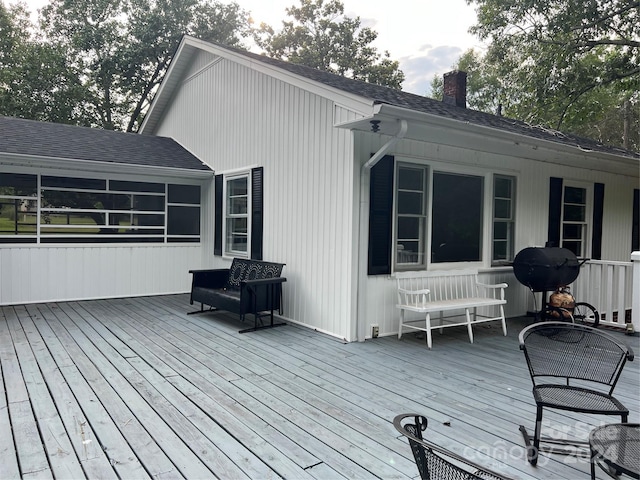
[{"xmin": 491, "ymin": 175, "xmax": 516, "ymax": 264}]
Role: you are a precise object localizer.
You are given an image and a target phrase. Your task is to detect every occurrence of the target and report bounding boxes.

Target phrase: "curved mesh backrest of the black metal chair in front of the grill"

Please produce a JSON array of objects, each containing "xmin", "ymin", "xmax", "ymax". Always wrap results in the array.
[{"xmin": 519, "ymin": 322, "xmax": 633, "ymax": 394}]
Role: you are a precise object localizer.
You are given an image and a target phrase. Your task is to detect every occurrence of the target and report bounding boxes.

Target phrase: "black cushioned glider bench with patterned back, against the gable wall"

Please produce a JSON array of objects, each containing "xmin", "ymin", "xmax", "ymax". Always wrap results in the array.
[{"xmin": 189, "ymin": 258, "xmax": 287, "ymax": 333}]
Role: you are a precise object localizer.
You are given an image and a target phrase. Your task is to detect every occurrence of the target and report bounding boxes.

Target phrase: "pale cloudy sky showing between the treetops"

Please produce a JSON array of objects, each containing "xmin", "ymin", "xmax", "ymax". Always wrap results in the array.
[{"xmin": 7, "ymin": 0, "xmax": 483, "ymax": 95}]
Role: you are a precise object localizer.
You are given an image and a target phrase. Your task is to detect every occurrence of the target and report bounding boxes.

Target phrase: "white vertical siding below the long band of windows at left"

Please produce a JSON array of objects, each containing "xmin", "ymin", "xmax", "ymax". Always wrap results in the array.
[{"xmin": 0, "ymin": 245, "xmax": 201, "ymax": 305}]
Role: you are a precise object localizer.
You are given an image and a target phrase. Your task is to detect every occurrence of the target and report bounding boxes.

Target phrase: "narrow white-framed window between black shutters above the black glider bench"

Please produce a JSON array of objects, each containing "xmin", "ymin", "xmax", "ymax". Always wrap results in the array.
[{"xmin": 225, "ymin": 173, "xmax": 250, "ymax": 256}]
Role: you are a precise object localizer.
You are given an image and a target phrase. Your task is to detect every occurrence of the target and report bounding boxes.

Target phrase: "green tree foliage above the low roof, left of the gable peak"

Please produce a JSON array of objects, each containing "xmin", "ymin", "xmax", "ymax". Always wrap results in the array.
[{"xmin": 0, "ymin": 0, "xmax": 250, "ymax": 131}]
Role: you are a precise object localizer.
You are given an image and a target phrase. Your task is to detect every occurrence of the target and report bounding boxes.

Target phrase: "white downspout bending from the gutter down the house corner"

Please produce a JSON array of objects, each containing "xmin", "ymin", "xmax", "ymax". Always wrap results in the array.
[{"xmin": 356, "ymin": 120, "xmax": 409, "ymax": 342}]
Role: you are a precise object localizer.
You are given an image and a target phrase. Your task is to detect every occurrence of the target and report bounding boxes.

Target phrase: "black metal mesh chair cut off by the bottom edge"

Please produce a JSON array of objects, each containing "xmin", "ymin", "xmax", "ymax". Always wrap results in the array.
[{"xmin": 393, "ymin": 413, "xmax": 509, "ymax": 480}]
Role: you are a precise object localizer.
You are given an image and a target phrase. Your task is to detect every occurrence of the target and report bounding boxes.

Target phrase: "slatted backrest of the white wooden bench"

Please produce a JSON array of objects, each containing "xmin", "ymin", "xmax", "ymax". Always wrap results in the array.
[{"xmin": 396, "ymin": 270, "xmax": 478, "ymax": 303}]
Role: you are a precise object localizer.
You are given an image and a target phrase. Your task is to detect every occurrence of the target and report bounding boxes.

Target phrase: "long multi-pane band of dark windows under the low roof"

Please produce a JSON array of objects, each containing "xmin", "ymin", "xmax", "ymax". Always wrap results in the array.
[{"xmin": 0, "ymin": 173, "xmax": 200, "ymax": 243}]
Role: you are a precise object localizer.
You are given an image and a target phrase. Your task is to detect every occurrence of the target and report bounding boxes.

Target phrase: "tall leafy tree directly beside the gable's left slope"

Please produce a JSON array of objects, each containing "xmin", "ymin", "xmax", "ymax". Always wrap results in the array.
[{"xmin": 35, "ymin": 0, "xmax": 250, "ymax": 131}]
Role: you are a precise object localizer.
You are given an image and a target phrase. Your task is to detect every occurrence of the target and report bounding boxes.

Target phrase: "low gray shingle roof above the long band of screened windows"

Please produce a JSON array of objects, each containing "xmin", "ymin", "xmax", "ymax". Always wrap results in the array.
[{"xmin": 0, "ymin": 116, "xmax": 210, "ymax": 171}]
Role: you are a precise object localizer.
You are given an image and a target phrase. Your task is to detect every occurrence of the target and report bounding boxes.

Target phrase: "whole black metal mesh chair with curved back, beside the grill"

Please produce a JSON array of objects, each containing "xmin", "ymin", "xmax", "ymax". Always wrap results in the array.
[{"xmin": 519, "ymin": 322, "xmax": 633, "ymax": 465}]
